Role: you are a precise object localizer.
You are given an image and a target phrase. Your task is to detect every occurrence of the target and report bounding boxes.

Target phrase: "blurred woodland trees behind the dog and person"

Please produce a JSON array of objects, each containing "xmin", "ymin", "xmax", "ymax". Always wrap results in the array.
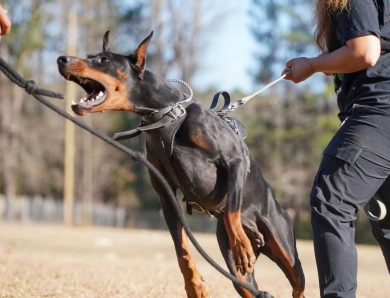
[{"xmin": 0, "ymin": 0, "xmax": 374, "ymax": 242}]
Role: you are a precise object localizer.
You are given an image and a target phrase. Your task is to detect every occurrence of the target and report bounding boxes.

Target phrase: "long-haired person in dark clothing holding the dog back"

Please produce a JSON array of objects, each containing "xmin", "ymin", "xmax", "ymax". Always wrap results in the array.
[{"xmin": 283, "ymin": 0, "xmax": 390, "ymax": 298}]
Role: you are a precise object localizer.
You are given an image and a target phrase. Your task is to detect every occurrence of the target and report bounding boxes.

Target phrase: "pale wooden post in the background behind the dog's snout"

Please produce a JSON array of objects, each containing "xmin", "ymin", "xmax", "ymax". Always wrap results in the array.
[{"xmin": 64, "ymin": 9, "xmax": 77, "ymax": 225}]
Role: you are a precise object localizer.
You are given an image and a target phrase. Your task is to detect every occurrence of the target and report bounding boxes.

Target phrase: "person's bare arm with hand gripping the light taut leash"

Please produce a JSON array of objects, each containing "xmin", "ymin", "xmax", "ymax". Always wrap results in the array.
[{"xmin": 283, "ymin": 35, "xmax": 381, "ymax": 83}]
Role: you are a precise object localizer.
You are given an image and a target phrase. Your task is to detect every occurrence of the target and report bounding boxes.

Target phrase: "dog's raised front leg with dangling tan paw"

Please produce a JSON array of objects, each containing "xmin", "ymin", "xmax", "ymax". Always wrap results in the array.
[{"xmin": 224, "ymin": 158, "xmax": 256, "ymax": 275}]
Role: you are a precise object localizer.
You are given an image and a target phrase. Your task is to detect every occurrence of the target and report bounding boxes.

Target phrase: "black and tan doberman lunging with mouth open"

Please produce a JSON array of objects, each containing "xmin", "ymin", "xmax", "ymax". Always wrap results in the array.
[{"xmin": 57, "ymin": 32, "xmax": 305, "ymax": 298}]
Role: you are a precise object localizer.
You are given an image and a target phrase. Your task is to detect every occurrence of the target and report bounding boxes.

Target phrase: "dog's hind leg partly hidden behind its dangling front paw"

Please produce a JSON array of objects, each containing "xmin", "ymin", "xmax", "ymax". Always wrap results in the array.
[{"xmin": 216, "ymin": 221, "xmax": 273, "ymax": 298}]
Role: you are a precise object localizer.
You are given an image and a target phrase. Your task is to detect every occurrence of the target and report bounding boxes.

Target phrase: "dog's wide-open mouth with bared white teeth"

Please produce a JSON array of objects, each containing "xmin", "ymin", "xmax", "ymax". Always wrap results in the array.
[{"xmin": 65, "ymin": 73, "xmax": 108, "ymax": 109}]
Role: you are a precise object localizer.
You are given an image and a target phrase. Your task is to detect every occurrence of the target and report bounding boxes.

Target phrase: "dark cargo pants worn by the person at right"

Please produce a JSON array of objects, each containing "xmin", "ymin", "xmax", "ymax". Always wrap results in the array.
[{"xmin": 310, "ymin": 107, "xmax": 390, "ymax": 298}]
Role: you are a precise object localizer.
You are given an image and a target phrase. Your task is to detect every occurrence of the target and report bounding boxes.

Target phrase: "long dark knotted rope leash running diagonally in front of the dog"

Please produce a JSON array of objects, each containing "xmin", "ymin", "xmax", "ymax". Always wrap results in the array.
[{"xmin": 0, "ymin": 58, "xmax": 263, "ymax": 297}]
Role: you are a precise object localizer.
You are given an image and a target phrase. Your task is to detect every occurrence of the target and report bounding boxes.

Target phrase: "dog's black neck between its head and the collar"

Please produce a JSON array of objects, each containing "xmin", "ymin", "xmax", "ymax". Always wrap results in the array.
[{"xmin": 130, "ymin": 70, "xmax": 184, "ymax": 116}]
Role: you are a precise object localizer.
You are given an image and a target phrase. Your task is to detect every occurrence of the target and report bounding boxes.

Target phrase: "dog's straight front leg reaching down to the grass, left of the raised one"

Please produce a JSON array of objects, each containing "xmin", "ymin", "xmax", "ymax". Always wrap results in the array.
[{"xmin": 149, "ymin": 158, "xmax": 209, "ymax": 298}]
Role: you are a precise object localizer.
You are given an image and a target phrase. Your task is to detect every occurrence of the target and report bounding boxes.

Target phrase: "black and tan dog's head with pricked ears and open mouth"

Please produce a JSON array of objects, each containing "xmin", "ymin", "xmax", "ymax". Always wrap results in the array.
[{"xmin": 57, "ymin": 31, "xmax": 153, "ymax": 116}]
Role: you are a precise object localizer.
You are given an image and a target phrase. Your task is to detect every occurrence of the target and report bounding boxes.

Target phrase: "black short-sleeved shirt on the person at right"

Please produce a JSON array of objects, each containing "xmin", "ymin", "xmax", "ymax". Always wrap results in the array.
[{"xmin": 329, "ymin": 0, "xmax": 390, "ymax": 120}]
